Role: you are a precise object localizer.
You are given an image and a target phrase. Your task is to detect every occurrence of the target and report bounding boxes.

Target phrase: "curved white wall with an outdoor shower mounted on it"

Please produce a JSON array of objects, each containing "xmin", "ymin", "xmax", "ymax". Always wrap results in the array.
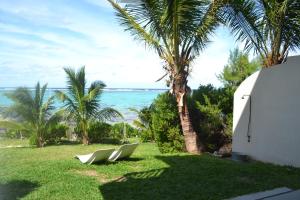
[{"xmin": 233, "ymin": 56, "xmax": 300, "ymax": 167}]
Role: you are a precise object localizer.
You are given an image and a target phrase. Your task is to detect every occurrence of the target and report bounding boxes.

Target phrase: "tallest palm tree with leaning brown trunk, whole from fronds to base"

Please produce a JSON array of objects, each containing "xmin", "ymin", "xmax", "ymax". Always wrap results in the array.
[{"xmin": 108, "ymin": 0, "xmax": 222, "ymax": 153}]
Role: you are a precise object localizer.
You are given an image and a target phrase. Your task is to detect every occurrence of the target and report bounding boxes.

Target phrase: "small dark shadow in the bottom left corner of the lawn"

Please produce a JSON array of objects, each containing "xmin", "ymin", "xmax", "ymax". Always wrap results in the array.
[{"xmin": 0, "ymin": 180, "xmax": 39, "ymax": 200}]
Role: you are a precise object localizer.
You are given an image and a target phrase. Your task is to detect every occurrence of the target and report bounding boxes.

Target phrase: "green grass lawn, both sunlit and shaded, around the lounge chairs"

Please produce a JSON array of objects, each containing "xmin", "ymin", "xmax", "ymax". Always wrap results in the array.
[{"xmin": 0, "ymin": 139, "xmax": 300, "ymax": 200}]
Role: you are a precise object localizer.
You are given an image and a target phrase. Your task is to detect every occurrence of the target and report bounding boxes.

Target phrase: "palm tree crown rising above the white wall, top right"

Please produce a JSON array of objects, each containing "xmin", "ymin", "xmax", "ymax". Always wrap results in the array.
[{"xmin": 223, "ymin": 0, "xmax": 300, "ymax": 67}]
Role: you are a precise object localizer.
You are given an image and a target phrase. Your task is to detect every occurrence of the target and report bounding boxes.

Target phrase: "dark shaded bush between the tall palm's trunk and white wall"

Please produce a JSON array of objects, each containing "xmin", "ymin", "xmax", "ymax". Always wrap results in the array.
[{"xmin": 188, "ymin": 85, "xmax": 233, "ymax": 152}]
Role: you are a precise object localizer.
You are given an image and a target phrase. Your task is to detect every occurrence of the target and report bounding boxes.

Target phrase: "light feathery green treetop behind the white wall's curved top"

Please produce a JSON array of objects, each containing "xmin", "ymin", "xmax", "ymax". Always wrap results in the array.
[{"xmin": 218, "ymin": 48, "xmax": 260, "ymax": 89}]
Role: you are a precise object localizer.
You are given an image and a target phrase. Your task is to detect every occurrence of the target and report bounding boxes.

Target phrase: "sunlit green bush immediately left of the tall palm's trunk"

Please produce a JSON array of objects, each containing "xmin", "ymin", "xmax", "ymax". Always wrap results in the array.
[{"xmin": 152, "ymin": 93, "xmax": 184, "ymax": 153}]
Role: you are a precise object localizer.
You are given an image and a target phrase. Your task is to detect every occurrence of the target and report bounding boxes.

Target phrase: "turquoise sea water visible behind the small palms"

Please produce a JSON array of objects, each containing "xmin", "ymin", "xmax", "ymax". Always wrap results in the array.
[{"xmin": 0, "ymin": 88, "xmax": 165, "ymax": 122}]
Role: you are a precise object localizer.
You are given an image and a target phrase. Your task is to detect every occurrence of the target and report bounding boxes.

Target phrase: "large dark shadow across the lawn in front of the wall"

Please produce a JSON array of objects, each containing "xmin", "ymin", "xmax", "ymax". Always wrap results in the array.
[{"xmin": 99, "ymin": 155, "xmax": 300, "ymax": 200}]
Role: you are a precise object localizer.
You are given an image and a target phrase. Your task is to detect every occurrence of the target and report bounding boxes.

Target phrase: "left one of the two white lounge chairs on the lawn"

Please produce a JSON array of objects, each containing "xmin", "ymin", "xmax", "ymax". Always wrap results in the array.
[{"xmin": 75, "ymin": 149, "xmax": 115, "ymax": 165}]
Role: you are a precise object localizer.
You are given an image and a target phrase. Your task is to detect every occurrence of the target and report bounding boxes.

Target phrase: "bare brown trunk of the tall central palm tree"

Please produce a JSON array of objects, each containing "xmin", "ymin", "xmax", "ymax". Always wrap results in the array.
[{"xmin": 173, "ymin": 77, "xmax": 204, "ymax": 154}]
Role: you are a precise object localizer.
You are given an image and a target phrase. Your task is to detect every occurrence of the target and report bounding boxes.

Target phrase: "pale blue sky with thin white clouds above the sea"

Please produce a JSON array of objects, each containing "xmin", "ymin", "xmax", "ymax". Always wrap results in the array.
[{"xmin": 0, "ymin": 0, "xmax": 238, "ymax": 88}]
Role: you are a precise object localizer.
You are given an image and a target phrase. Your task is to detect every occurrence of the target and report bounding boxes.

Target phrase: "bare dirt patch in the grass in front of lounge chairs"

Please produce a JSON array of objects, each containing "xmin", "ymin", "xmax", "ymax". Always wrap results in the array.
[{"xmin": 72, "ymin": 170, "xmax": 127, "ymax": 183}]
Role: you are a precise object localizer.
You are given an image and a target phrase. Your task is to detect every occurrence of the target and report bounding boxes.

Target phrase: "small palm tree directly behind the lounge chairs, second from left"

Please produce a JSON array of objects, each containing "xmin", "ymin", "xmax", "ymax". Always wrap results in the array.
[{"xmin": 56, "ymin": 67, "xmax": 122, "ymax": 144}]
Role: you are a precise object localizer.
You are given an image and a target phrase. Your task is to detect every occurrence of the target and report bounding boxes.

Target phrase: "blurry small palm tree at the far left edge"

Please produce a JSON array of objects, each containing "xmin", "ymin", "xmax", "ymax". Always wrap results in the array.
[{"xmin": 0, "ymin": 83, "xmax": 61, "ymax": 147}]
